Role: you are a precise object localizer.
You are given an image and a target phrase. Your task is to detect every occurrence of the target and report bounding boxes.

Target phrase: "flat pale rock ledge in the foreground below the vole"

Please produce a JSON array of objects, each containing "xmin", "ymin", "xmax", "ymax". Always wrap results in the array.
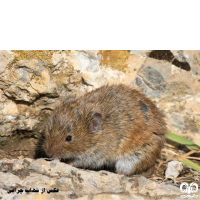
[{"xmin": 0, "ymin": 158, "xmax": 184, "ymax": 199}]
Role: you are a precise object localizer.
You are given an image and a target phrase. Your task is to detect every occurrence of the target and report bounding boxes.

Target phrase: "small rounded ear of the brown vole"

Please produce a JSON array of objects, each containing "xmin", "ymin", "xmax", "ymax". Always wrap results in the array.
[{"xmin": 88, "ymin": 113, "xmax": 102, "ymax": 133}]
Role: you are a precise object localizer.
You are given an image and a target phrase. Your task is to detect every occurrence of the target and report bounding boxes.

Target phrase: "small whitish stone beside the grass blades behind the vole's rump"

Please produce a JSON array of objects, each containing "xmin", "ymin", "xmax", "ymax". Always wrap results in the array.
[{"xmin": 165, "ymin": 161, "xmax": 183, "ymax": 180}]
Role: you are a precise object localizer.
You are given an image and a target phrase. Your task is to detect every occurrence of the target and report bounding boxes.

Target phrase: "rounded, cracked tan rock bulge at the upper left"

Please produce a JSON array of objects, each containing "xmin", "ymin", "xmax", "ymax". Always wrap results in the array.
[{"xmin": 0, "ymin": 59, "xmax": 58, "ymax": 102}]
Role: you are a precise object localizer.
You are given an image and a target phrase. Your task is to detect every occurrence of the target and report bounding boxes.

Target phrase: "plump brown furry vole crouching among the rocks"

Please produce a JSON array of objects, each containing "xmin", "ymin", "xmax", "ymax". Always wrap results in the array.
[{"xmin": 43, "ymin": 84, "xmax": 166, "ymax": 175}]
